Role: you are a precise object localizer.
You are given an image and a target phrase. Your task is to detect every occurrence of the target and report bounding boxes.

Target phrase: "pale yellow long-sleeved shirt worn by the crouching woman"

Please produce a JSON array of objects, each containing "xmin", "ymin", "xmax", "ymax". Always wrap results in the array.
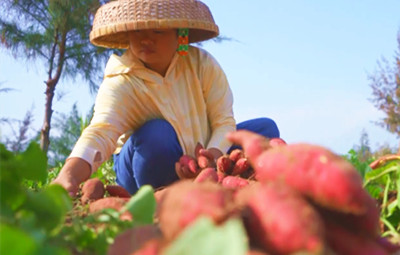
[{"xmin": 69, "ymin": 47, "xmax": 236, "ymax": 171}]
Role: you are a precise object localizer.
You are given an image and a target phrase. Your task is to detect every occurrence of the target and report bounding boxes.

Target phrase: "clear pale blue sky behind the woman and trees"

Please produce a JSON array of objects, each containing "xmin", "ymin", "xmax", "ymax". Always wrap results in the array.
[{"xmin": 0, "ymin": 0, "xmax": 400, "ymax": 153}]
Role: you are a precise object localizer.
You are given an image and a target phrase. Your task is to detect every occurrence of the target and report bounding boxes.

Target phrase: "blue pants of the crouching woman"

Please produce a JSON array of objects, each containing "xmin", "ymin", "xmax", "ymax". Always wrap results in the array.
[{"xmin": 114, "ymin": 118, "xmax": 279, "ymax": 194}]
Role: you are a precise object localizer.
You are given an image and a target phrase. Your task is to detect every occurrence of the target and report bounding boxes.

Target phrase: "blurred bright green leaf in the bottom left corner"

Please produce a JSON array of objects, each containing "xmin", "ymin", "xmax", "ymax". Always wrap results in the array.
[{"xmin": 0, "ymin": 223, "xmax": 38, "ymax": 255}]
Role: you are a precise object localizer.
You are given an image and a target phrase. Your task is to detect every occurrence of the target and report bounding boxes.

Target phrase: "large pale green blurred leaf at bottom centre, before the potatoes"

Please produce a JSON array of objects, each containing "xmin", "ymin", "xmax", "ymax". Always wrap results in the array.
[{"xmin": 164, "ymin": 217, "xmax": 249, "ymax": 255}]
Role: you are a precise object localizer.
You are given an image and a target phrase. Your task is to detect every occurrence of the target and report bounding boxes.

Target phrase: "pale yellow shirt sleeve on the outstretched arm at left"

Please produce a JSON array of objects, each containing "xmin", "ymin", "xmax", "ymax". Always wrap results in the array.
[{"xmin": 69, "ymin": 75, "xmax": 133, "ymax": 173}]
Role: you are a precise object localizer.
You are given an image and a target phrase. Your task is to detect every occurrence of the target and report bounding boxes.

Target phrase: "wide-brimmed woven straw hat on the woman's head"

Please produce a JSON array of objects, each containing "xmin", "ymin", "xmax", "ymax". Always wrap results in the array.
[{"xmin": 90, "ymin": 0, "xmax": 219, "ymax": 48}]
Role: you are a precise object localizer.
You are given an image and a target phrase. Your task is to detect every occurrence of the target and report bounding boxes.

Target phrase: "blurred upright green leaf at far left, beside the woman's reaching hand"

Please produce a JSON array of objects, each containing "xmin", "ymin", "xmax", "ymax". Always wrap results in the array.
[{"xmin": 17, "ymin": 142, "xmax": 47, "ymax": 182}]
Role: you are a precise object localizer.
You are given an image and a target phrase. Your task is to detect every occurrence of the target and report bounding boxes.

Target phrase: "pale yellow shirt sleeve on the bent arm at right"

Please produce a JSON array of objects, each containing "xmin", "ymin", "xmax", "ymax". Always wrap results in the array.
[{"xmin": 200, "ymin": 50, "xmax": 236, "ymax": 153}]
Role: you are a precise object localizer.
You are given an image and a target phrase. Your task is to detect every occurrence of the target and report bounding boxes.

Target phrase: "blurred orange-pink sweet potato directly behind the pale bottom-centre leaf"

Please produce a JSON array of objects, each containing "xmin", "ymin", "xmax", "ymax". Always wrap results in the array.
[{"xmin": 159, "ymin": 180, "xmax": 233, "ymax": 240}]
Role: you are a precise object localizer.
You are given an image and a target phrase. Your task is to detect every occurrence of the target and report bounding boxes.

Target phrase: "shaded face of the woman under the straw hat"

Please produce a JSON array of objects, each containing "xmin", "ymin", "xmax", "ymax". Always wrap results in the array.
[{"xmin": 129, "ymin": 29, "xmax": 178, "ymax": 72}]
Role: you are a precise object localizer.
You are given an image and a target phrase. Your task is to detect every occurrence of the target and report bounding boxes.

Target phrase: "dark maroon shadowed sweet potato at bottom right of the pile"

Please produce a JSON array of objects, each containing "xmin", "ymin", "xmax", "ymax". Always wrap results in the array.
[{"xmin": 324, "ymin": 221, "xmax": 389, "ymax": 255}]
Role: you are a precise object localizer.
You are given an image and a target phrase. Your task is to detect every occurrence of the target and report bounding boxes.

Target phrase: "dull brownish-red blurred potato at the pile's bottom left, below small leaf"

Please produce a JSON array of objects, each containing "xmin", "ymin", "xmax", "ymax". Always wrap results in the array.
[{"xmin": 107, "ymin": 225, "xmax": 162, "ymax": 255}]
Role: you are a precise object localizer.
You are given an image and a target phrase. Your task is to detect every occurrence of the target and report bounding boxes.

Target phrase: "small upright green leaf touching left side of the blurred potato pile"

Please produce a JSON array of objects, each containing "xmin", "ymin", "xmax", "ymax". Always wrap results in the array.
[{"xmin": 121, "ymin": 185, "xmax": 156, "ymax": 224}]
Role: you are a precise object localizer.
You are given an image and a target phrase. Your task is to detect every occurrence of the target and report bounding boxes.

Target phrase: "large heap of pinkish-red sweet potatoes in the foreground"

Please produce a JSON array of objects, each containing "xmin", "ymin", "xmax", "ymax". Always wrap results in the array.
[{"xmin": 79, "ymin": 131, "xmax": 400, "ymax": 255}]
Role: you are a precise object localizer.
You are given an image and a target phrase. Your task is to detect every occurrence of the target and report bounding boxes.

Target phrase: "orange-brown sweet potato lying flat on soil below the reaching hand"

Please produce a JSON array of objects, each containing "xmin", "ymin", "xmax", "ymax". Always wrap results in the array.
[{"xmin": 89, "ymin": 197, "xmax": 132, "ymax": 220}]
